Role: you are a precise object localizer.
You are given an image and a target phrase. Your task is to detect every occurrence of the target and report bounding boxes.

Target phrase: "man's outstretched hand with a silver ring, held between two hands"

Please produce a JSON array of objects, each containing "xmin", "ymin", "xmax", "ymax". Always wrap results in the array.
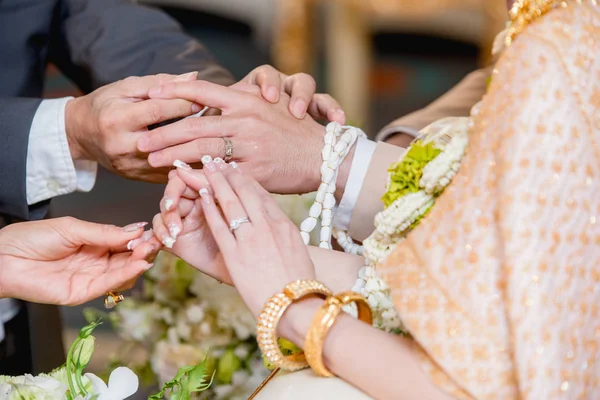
[{"xmin": 138, "ymin": 81, "xmax": 330, "ymax": 194}]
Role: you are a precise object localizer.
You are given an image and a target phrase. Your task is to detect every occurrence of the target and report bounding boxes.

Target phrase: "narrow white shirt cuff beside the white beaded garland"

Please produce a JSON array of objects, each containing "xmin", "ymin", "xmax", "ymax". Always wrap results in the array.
[{"xmin": 333, "ymin": 138, "xmax": 376, "ymax": 230}]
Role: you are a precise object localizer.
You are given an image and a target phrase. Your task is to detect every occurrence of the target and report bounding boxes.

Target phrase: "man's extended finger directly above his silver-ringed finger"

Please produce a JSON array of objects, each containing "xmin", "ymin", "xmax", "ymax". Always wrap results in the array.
[{"xmin": 137, "ymin": 115, "xmax": 245, "ymax": 153}]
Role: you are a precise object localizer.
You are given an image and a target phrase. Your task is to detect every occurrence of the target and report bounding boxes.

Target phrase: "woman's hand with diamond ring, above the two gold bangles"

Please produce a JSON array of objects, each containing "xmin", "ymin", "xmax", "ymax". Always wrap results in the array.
[{"xmin": 185, "ymin": 162, "xmax": 316, "ymax": 316}]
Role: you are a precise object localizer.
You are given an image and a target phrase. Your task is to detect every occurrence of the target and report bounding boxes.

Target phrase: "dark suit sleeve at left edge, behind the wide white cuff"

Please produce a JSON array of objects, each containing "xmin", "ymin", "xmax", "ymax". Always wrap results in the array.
[{"xmin": 0, "ymin": 97, "xmax": 48, "ymax": 221}]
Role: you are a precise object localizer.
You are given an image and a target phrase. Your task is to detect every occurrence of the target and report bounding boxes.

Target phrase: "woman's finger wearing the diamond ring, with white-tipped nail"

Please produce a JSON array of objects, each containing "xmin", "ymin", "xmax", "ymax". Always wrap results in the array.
[{"xmin": 204, "ymin": 161, "xmax": 252, "ymax": 238}]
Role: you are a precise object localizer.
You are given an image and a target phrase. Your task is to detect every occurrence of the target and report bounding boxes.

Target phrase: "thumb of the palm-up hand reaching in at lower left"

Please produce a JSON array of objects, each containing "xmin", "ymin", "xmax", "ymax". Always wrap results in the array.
[{"xmin": 63, "ymin": 219, "xmax": 148, "ymax": 249}]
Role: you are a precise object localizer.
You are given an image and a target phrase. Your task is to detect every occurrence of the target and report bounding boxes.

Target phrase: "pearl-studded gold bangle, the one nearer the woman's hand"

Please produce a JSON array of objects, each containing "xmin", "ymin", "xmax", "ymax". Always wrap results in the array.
[{"xmin": 256, "ymin": 280, "xmax": 331, "ymax": 371}]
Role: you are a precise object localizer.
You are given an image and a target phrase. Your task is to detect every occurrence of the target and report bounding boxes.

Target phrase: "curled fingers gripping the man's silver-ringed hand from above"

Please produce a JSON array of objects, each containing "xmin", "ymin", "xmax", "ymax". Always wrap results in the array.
[{"xmin": 233, "ymin": 65, "xmax": 346, "ymax": 125}]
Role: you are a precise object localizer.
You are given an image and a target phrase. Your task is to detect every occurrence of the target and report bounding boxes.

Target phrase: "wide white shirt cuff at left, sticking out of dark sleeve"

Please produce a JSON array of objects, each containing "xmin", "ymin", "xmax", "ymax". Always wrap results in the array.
[{"xmin": 26, "ymin": 97, "xmax": 98, "ymax": 205}]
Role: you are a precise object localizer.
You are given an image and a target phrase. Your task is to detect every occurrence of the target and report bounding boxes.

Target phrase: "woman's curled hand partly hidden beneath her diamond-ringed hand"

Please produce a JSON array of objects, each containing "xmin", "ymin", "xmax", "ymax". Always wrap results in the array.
[{"xmin": 150, "ymin": 169, "xmax": 232, "ymax": 285}]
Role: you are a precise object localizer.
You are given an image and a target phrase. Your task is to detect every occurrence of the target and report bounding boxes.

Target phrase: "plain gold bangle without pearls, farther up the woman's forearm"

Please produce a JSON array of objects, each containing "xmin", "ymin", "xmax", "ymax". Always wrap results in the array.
[{"xmin": 304, "ymin": 292, "xmax": 373, "ymax": 377}]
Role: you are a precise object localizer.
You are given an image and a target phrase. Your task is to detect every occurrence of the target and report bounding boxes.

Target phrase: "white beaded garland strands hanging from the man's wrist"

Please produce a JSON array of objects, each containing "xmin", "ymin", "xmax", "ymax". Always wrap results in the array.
[{"xmin": 300, "ymin": 122, "xmax": 367, "ymax": 249}]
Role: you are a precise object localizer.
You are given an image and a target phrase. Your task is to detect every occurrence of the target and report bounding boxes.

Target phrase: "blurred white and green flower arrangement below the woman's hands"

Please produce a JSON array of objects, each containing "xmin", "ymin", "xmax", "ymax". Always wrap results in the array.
[{"xmin": 94, "ymin": 195, "xmax": 314, "ymax": 400}]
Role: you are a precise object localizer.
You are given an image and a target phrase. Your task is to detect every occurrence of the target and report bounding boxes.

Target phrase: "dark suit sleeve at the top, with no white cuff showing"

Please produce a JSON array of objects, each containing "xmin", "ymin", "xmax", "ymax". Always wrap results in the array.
[{"xmin": 50, "ymin": 0, "xmax": 234, "ymax": 92}]
